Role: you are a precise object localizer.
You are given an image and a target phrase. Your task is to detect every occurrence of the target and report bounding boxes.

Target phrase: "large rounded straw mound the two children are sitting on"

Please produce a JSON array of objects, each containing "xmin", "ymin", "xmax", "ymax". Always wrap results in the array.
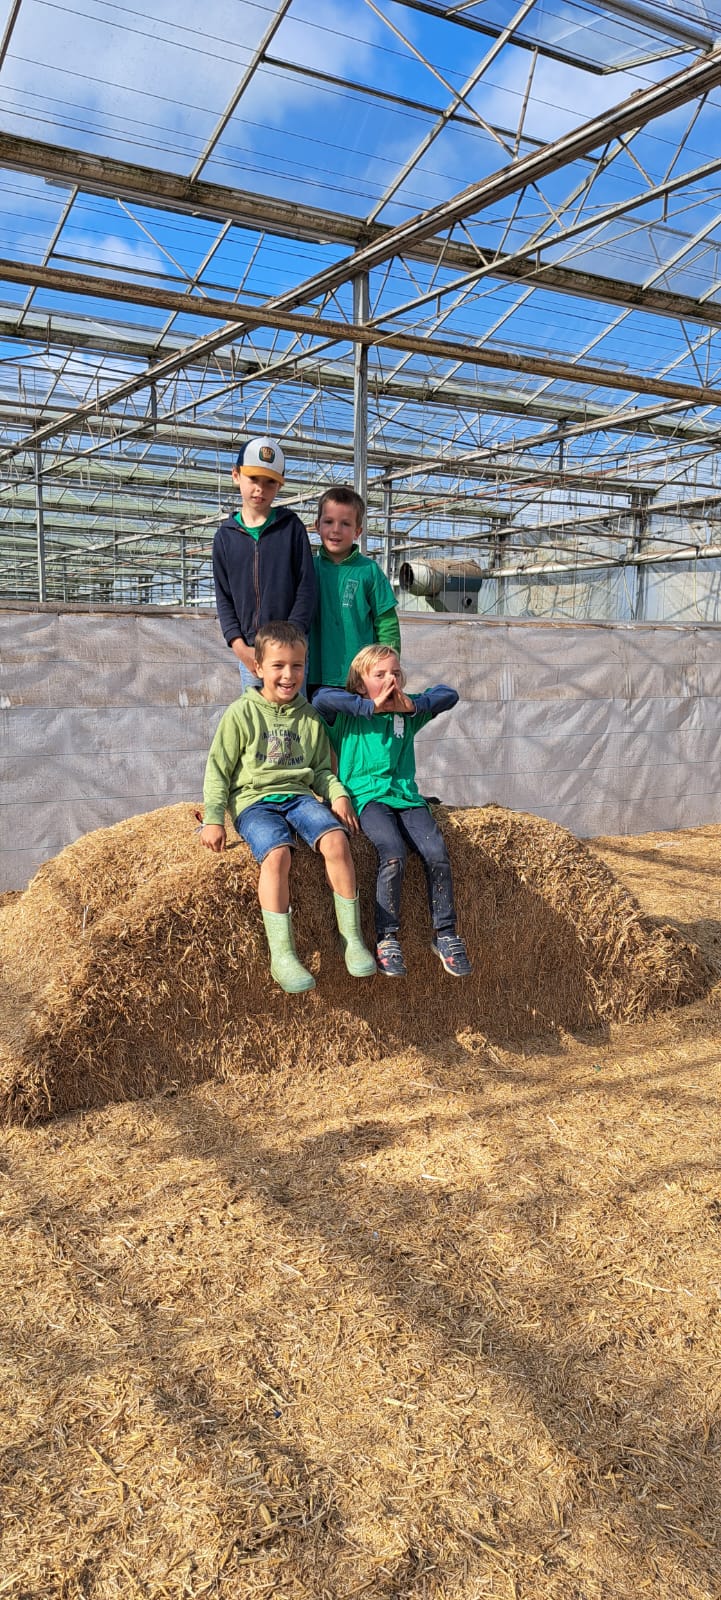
[{"xmin": 0, "ymin": 805, "xmax": 708, "ymax": 1122}]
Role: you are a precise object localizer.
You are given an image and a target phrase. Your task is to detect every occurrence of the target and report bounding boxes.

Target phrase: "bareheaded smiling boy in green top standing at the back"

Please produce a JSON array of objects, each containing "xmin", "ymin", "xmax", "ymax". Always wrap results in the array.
[{"xmin": 309, "ymin": 483, "xmax": 401, "ymax": 693}]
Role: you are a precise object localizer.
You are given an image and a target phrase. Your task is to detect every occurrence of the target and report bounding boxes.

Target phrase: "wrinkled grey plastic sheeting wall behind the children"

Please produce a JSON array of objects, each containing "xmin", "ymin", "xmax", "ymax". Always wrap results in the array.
[{"xmin": 0, "ymin": 606, "xmax": 721, "ymax": 890}]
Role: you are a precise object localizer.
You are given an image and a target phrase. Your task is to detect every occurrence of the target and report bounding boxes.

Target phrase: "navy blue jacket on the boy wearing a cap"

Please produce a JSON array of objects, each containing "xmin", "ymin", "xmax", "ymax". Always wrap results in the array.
[{"xmin": 213, "ymin": 506, "xmax": 315, "ymax": 645}]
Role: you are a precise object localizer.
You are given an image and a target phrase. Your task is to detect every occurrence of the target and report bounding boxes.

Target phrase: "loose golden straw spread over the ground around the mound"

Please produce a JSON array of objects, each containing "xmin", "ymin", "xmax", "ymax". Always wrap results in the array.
[{"xmin": 0, "ymin": 832, "xmax": 721, "ymax": 1600}]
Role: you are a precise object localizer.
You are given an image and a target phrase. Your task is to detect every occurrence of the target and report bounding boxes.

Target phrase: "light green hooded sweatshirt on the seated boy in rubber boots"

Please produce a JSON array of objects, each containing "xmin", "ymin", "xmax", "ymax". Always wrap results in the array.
[{"xmin": 203, "ymin": 688, "xmax": 347, "ymax": 824}]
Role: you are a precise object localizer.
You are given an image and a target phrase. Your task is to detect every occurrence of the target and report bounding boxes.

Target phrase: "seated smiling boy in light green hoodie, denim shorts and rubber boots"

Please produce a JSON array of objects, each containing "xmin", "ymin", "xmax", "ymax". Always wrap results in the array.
[{"xmin": 200, "ymin": 622, "xmax": 376, "ymax": 994}]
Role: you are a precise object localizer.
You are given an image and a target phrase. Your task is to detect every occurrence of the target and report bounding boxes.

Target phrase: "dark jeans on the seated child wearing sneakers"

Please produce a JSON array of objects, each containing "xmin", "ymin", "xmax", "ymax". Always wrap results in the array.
[{"xmin": 360, "ymin": 800, "xmax": 456, "ymax": 941}]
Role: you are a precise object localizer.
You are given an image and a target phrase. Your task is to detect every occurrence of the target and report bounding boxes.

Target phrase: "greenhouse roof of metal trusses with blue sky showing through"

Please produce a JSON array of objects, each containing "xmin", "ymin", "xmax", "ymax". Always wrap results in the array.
[{"xmin": 0, "ymin": 0, "xmax": 721, "ymax": 616}]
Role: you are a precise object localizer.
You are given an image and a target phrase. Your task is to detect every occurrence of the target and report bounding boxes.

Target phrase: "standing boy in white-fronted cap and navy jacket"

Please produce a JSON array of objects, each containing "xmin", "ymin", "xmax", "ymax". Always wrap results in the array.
[{"xmin": 213, "ymin": 438, "xmax": 317, "ymax": 690}]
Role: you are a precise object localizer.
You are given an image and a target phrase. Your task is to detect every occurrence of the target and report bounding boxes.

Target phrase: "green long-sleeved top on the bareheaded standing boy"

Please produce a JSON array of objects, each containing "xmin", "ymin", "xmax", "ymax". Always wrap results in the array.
[{"xmin": 309, "ymin": 544, "xmax": 401, "ymax": 686}]
